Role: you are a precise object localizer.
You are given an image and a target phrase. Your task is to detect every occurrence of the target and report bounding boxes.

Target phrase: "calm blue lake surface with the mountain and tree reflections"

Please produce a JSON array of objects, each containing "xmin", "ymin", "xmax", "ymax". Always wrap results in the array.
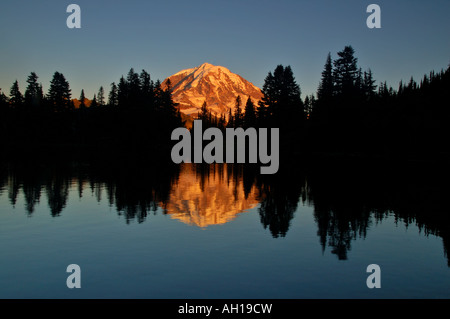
[{"xmin": 0, "ymin": 163, "xmax": 450, "ymax": 299}]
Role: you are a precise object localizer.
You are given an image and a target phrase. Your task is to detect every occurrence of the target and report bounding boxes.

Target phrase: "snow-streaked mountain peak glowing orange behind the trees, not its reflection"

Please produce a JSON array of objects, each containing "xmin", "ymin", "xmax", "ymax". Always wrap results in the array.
[{"xmin": 163, "ymin": 63, "xmax": 263, "ymax": 117}]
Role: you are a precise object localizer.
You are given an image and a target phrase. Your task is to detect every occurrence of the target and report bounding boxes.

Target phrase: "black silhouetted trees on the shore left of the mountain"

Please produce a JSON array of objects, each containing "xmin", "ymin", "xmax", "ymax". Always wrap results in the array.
[{"xmin": 0, "ymin": 68, "xmax": 183, "ymax": 156}]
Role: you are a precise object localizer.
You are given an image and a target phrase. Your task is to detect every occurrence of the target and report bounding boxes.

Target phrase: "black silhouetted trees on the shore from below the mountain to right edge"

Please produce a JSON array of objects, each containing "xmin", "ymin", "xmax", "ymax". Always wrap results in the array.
[{"xmin": 205, "ymin": 46, "xmax": 450, "ymax": 159}]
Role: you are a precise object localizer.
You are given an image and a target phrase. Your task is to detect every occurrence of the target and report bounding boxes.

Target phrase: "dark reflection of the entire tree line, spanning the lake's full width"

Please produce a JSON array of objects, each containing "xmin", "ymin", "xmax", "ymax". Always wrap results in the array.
[{"xmin": 0, "ymin": 162, "xmax": 450, "ymax": 266}]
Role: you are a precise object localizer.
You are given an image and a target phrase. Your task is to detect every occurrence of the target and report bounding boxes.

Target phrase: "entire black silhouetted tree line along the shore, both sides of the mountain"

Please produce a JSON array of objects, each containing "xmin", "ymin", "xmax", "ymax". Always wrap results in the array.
[{"xmin": 0, "ymin": 46, "xmax": 450, "ymax": 157}]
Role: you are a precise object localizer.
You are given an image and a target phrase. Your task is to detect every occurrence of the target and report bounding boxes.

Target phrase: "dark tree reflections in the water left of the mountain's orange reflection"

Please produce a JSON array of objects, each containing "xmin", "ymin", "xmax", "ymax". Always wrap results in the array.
[{"xmin": 0, "ymin": 163, "xmax": 179, "ymax": 223}]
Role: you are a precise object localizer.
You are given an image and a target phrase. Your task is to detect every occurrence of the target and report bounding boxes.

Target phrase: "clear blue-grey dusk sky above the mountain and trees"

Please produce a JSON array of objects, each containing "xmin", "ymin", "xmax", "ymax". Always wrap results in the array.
[{"xmin": 0, "ymin": 0, "xmax": 450, "ymax": 98}]
